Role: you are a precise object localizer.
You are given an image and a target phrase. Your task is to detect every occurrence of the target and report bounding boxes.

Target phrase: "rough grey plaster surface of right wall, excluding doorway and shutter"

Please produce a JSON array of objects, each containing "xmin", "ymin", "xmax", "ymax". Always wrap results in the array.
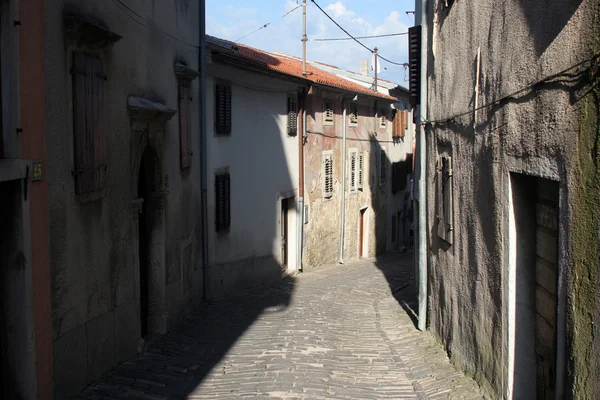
[{"xmin": 426, "ymin": 0, "xmax": 598, "ymax": 397}]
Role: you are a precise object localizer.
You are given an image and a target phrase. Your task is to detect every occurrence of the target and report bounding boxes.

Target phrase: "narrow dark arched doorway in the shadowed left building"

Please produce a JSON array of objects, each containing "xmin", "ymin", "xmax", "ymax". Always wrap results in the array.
[{"xmin": 138, "ymin": 148, "xmax": 155, "ymax": 337}]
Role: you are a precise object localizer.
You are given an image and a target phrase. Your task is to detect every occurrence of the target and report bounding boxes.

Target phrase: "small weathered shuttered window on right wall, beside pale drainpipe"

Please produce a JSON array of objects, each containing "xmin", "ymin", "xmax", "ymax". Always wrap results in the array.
[{"xmin": 436, "ymin": 156, "xmax": 454, "ymax": 244}]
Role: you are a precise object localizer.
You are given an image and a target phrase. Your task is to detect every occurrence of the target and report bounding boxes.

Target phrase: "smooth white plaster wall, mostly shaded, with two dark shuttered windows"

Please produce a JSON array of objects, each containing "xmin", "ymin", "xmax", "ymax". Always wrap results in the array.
[{"xmin": 206, "ymin": 61, "xmax": 301, "ymax": 297}]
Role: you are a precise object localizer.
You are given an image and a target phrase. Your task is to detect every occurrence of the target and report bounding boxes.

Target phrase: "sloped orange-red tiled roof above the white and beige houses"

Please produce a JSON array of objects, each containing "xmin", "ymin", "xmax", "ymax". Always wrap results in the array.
[{"xmin": 206, "ymin": 35, "xmax": 397, "ymax": 101}]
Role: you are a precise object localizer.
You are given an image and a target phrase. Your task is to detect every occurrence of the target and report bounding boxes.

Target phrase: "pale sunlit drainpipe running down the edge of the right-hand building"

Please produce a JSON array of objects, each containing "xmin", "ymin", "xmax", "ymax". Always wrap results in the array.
[{"xmin": 415, "ymin": 0, "xmax": 427, "ymax": 331}]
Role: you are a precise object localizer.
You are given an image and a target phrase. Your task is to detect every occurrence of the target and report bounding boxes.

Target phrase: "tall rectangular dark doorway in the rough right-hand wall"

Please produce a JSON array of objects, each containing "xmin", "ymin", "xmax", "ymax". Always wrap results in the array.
[{"xmin": 511, "ymin": 174, "xmax": 559, "ymax": 400}]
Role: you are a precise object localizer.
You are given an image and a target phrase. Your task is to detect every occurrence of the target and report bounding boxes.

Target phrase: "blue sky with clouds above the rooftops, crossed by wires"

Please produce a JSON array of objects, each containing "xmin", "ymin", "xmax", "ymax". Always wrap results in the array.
[{"xmin": 206, "ymin": 0, "xmax": 414, "ymax": 86}]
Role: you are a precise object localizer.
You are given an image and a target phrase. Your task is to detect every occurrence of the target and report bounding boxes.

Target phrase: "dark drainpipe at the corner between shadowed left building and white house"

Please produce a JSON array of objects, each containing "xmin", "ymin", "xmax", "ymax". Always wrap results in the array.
[{"xmin": 198, "ymin": 1, "xmax": 210, "ymax": 301}]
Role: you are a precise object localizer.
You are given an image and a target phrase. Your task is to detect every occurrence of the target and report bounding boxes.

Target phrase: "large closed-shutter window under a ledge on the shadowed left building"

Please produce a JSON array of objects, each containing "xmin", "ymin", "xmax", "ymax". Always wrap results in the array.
[{"xmin": 72, "ymin": 52, "xmax": 106, "ymax": 194}]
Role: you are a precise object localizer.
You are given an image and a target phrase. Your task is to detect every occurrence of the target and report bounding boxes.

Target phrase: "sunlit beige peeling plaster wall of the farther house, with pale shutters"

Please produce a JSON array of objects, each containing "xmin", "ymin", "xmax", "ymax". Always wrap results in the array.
[{"xmin": 303, "ymin": 87, "xmax": 411, "ymax": 270}]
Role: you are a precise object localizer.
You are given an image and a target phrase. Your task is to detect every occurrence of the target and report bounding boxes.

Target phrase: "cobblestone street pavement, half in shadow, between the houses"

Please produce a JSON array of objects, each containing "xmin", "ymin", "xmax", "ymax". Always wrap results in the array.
[{"xmin": 75, "ymin": 254, "xmax": 483, "ymax": 400}]
